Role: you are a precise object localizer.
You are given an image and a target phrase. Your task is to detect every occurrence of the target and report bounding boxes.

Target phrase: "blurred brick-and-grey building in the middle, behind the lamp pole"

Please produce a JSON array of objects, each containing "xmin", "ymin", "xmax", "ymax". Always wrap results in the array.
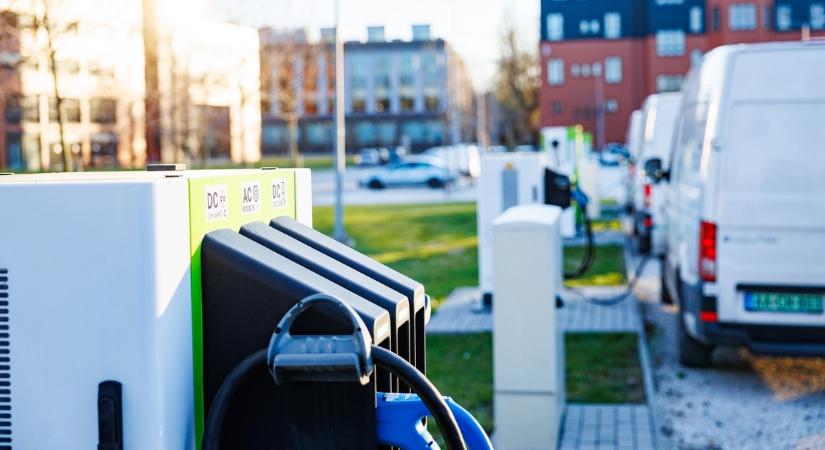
[{"xmin": 260, "ymin": 25, "xmax": 476, "ymax": 154}]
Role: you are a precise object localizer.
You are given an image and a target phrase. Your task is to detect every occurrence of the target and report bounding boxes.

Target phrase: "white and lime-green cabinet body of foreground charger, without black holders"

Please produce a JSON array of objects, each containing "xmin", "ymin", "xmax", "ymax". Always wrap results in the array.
[{"xmin": 0, "ymin": 169, "xmax": 312, "ymax": 450}]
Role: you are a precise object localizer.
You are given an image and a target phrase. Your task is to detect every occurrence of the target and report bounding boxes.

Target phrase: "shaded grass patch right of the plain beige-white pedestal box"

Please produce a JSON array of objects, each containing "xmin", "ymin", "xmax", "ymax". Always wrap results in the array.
[{"xmin": 565, "ymin": 333, "xmax": 645, "ymax": 403}]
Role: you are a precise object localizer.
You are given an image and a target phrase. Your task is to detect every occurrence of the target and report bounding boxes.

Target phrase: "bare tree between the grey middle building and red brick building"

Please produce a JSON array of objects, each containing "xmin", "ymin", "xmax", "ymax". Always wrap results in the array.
[{"xmin": 495, "ymin": 25, "xmax": 541, "ymax": 146}]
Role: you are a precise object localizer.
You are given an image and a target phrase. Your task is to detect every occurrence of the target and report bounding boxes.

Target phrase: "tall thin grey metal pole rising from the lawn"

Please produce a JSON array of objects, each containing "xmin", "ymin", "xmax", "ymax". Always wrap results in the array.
[{"xmin": 332, "ymin": 0, "xmax": 350, "ymax": 243}]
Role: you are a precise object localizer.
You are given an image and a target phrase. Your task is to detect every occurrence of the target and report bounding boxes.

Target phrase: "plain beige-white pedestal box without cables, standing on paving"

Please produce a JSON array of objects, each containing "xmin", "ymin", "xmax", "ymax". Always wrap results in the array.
[{"xmin": 492, "ymin": 205, "xmax": 564, "ymax": 450}]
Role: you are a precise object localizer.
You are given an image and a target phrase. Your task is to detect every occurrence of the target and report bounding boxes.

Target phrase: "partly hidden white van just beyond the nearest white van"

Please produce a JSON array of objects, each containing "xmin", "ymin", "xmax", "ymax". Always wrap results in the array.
[{"xmin": 633, "ymin": 92, "xmax": 682, "ymax": 256}]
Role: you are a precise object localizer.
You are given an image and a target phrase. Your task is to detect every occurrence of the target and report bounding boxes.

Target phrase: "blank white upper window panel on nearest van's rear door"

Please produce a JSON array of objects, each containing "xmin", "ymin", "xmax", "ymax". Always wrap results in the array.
[{"xmin": 722, "ymin": 100, "xmax": 825, "ymax": 194}]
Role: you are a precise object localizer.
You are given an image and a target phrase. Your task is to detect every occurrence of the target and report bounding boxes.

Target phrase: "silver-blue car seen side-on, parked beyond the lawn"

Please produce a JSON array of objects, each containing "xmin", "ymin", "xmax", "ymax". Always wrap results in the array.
[{"xmin": 360, "ymin": 156, "xmax": 455, "ymax": 189}]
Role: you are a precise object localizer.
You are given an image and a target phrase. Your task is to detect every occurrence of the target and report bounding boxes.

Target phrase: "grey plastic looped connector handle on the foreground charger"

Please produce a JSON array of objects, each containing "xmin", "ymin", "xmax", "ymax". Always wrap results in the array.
[{"xmin": 266, "ymin": 293, "xmax": 375, "ymax": 385}]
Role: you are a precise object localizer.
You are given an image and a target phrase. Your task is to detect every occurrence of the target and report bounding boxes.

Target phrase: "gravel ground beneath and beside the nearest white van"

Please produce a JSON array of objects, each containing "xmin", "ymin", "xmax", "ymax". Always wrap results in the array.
[{"xmin": 637, "ymin": 262, "xmax": 825, "ymax": 450}]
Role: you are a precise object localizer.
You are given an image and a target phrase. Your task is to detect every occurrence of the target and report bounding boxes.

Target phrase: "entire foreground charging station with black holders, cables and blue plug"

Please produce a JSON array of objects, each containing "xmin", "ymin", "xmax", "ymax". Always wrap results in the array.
[{"xmin": 0, "ymin": 166, "xmax": 491, "ymax": 450}]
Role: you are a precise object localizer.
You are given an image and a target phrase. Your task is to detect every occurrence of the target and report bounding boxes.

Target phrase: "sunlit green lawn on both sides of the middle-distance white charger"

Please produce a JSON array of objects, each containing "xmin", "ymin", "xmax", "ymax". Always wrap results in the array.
[{"xmin": 314, "ymin": 203, "xmax": 626, "ymax": 307}]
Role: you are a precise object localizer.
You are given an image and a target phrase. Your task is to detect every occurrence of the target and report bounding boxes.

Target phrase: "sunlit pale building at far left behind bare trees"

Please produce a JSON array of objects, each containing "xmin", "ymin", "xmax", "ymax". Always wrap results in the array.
[{"xmin": 0, "ymin": 0, "xmax": 260, "ymax": 172}]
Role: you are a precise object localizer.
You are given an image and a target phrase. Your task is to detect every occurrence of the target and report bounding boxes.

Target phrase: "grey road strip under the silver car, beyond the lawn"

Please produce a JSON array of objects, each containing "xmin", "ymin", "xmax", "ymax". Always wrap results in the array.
[{"xmin": 312, "ymin": 167, "xmax": 476, "ymax": 206}]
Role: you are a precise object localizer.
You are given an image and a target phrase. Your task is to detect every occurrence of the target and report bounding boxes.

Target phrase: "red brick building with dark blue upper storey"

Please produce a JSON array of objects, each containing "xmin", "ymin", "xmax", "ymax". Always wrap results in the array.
[{"xmin": 539, "ymin": 0, "xmax": 825, "ymax": 147}]
